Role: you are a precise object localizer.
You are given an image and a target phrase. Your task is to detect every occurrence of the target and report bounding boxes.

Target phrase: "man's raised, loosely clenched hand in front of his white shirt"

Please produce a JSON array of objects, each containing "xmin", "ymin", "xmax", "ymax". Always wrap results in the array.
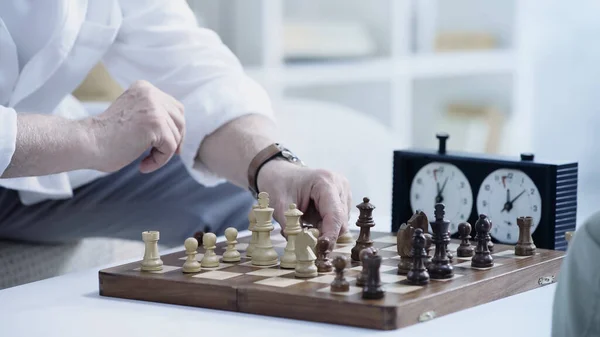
[{"xmin": 84, "ymin": 81, "xmax": 185, "ymax": 173}]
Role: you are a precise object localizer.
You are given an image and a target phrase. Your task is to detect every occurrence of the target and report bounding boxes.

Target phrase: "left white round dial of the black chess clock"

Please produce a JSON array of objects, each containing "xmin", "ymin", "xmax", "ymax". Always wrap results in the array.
[{"xmin": 410, "ymin": 162, "xmax": 473, "ymax": 234}]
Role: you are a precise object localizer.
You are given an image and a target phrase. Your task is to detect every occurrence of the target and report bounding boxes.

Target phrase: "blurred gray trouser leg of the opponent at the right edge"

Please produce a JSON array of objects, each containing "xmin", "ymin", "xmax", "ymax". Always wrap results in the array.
[{"xmin": 552, "ymin": 213, "xmax": 600, "ymax": 337}]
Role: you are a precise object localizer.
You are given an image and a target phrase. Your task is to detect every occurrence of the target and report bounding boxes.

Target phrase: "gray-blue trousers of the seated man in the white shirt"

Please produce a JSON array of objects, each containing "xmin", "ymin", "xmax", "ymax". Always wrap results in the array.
[{"xmin": 0, "ymin": 156, "xmax": 254, "ymax": 246}]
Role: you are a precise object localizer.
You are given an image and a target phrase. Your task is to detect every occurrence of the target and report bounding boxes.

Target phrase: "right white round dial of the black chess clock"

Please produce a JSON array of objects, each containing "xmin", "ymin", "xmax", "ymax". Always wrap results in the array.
[{"xmin": 477, "ymin": 169, "xmax": 542, "ymax": 244}]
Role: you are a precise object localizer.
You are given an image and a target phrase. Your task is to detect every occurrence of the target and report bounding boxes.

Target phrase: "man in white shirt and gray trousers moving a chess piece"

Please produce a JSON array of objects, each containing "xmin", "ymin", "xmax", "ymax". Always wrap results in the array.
[{"xmin": 0, "ymin": 0, "xmax": 352, "ymax": 244}]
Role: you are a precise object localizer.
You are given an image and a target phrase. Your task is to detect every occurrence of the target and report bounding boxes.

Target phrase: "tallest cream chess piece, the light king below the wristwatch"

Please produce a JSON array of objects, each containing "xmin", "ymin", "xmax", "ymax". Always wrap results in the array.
[{"xmin": 252, "ymin": 192, "xmax": 279, "ymax": 266}]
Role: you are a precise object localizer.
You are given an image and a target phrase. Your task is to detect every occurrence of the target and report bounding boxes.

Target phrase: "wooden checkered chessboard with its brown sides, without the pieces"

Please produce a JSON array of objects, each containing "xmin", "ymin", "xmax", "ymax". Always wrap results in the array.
[{"xmin": 100, "ymin": 230, "xmax": 563, "ymax": 329}]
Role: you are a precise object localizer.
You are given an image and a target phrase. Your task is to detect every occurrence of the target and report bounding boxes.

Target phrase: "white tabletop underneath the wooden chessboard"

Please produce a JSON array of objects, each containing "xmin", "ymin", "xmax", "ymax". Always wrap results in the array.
[{"xmin": 0, "ymin": 228, "xmax": 555, "ymax": 337}]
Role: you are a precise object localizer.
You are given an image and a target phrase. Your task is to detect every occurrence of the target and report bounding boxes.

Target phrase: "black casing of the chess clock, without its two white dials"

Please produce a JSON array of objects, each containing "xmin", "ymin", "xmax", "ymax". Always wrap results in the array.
[{"xmin": 392, "ymin": 136, "xmax": 578, "ymax": 250}]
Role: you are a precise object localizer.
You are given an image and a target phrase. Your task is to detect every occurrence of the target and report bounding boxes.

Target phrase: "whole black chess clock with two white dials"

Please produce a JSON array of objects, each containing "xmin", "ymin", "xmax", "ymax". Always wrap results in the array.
[{"xmin": 392, "ymin": 133, "xmax": 578, "ymax": 250}]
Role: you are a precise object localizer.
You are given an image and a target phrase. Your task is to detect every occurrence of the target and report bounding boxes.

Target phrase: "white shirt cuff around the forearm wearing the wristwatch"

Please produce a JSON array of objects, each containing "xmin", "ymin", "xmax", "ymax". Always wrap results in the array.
[{"xmin": 181, "ymin": 75, "xmax": 275, "ymax": 187}]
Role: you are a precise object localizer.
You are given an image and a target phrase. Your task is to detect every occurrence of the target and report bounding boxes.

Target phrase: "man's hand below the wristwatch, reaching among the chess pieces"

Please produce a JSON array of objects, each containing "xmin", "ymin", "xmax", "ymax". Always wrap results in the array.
[{"xmin": 258, "ymin": 160, "xmax": 352, "ymax": 242}]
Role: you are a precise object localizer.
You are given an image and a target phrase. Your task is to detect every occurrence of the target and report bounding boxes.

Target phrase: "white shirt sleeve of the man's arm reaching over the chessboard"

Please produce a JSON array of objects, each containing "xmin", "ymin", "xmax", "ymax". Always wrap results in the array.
[{"xmin": 103, "ymin": 0, "xmax": 273, "ymax": 186}]
